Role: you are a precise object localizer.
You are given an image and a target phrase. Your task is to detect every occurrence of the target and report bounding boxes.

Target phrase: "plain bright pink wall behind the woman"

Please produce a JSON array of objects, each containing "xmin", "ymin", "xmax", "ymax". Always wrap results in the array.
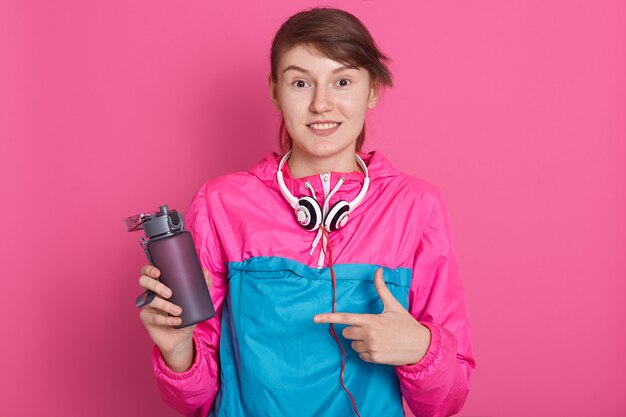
[{"xmin": 0, "ymin": 0, "xmax": 626, "ymax": 417}]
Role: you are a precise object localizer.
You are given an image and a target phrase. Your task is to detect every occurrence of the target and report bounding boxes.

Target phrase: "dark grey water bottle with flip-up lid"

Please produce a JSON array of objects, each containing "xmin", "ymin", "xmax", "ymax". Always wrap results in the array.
[{"xmin": 124, "ymin": 205, "xmax": 215, "ymax": 329}]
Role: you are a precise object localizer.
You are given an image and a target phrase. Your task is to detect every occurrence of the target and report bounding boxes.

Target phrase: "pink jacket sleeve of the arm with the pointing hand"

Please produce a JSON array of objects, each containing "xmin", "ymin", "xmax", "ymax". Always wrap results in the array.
[{"xmin": 396, "ymin": 194, "xmax": 476, "ymax": 417}]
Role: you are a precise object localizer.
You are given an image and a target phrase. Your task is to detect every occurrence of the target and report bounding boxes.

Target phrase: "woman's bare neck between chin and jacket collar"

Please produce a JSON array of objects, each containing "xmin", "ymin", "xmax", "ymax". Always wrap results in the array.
[{"xmin": 287, "ymin": 148, "xmax": 362, "ymax": 178}]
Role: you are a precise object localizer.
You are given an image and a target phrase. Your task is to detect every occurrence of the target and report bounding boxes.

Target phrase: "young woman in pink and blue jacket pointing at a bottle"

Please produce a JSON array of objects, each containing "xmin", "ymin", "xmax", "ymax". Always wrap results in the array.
[{"xmin": 139, "ymin": 8, "xmax": 475, "ymax": 417}]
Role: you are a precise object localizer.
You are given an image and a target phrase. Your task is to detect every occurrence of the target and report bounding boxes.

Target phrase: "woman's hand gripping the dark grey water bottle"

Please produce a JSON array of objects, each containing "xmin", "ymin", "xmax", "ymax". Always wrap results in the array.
[{"xmin": 139, "ymin": 265, "xmax": 211, "ymax": 372}]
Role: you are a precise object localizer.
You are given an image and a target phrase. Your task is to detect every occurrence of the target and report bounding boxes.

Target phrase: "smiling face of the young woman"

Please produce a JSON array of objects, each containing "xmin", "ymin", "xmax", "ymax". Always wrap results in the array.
[{"xmin": 270, "ymin": 46, "xmax": 377, "ymax": 159}]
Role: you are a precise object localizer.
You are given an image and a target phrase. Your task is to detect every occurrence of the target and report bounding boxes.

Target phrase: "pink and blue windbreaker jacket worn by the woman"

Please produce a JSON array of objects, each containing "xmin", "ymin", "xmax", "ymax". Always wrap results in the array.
[{"xmin": 152, "ymin": 151, "xmax": 475, "ymax": 417}]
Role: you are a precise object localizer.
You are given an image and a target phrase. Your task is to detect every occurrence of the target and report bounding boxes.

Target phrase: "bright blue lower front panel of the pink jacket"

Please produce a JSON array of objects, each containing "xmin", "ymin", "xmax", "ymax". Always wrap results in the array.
[{"xmin": 210, "ymin": 257, "xmax": 411, "ymax": 417}]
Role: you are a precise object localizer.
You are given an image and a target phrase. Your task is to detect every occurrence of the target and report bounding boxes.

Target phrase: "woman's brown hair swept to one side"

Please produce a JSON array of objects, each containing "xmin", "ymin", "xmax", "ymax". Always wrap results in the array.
[{"xmin": 270, "ymin": 7, "xmax": 393, "ymax": 152}]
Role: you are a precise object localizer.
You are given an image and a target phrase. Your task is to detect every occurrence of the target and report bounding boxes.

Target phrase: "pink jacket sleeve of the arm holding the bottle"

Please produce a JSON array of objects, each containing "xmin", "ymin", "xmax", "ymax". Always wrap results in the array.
[{"xmin": 152, "ymin": 182, "xmax": 228, "ymax": 416}]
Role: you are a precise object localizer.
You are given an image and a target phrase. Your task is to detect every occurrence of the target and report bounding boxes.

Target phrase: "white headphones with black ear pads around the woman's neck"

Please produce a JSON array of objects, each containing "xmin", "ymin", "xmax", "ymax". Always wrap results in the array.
[{"xmin": 276, "ymin": 150, "xmax": 370, "ymax": 232}]
